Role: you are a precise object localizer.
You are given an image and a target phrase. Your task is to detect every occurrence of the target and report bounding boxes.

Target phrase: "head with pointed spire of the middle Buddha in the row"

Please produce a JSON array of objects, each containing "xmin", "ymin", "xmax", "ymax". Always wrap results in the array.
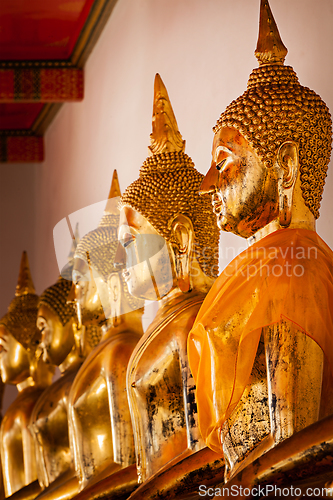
[{"xmin": 73, "ymin": 170, "xmax": 143, "ymax": 333}]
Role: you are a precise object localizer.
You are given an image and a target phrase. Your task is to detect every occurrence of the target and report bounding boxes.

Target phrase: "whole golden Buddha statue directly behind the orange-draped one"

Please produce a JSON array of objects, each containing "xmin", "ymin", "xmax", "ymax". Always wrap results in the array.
[{"xmin": 86, "ymin": 75, "xmax": 223, "ymax": 500}]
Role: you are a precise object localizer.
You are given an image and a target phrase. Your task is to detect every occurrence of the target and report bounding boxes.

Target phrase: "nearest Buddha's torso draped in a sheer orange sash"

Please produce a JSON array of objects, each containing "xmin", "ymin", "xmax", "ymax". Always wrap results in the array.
[{"xmin": 189, "ymin": 229, "xmax": 333, "ymax": 479}]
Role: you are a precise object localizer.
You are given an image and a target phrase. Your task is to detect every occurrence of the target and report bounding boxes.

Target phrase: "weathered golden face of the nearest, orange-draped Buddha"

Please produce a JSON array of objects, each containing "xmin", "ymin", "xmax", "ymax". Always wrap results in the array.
[{"xmin": 200, "ymin": 127, "xmax": 279, "ymax": 238}]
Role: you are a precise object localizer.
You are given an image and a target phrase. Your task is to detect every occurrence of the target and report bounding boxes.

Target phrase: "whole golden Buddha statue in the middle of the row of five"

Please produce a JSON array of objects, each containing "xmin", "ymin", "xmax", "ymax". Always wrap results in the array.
[{"xmin": 35, "ymin": 171, "xmax": 143, "ymax": 499}]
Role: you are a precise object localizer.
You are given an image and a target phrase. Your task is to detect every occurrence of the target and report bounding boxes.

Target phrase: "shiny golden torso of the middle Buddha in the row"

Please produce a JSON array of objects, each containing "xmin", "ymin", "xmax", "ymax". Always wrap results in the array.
[{"xmin": 70, "ymin": 331, "xmax": 140, "ymax": 489}]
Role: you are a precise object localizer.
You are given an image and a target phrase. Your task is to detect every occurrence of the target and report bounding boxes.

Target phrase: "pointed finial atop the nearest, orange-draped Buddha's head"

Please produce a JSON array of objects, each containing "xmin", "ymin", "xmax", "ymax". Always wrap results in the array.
[{"xmin": 254, "ymin": 0, "xmax": 288, "ymax": 66}]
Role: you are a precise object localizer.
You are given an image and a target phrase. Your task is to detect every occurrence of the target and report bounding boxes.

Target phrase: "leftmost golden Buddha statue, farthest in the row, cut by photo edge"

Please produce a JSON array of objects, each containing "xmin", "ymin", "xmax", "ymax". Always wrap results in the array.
[{"xmin": 0, "ymin": 252, "xmax": 54, "ymax": 497}]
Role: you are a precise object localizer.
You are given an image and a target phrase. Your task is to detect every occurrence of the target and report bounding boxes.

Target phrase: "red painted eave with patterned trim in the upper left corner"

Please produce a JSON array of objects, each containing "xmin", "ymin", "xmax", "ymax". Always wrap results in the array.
[{"xmin": 0, "ymin": 0, "xmax": 117, "ymax": 162}]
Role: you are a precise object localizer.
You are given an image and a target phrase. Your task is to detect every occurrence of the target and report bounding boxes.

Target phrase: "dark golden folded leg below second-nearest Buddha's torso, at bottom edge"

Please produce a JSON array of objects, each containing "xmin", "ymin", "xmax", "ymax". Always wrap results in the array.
[{"xmin": 126, "ymin": 447, "xmax": 224, "ymax": 500}]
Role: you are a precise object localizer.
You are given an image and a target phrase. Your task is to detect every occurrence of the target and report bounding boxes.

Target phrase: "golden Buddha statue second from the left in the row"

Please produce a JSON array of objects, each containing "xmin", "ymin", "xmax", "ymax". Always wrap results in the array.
[{"xmin": 22, "ymin": 237, "xmax": 83, "ymax": 500}]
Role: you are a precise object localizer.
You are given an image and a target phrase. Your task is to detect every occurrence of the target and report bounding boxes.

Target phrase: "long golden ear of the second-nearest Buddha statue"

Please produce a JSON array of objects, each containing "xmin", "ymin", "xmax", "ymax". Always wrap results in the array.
[{"xmin": 168, "ymin": 214, "xmax": 194, "ymax": 293}]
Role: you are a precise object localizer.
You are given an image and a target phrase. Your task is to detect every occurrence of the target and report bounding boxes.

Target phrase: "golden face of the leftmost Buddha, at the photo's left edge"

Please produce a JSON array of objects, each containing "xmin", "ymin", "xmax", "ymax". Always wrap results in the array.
[{"xmin": 0, "ymin": 325, "xmax": 30, "ymax": 385}]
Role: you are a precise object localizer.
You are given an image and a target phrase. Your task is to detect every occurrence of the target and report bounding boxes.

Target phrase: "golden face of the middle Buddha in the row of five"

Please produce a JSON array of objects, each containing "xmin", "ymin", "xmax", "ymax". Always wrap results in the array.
[{"xmin": 73, "ymin": 258, "xmax": 110, "ymax": 326}]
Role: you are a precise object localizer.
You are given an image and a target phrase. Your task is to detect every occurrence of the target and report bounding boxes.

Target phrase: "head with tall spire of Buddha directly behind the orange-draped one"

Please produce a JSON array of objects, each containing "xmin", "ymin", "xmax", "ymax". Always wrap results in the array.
[{"xmin": 119, "ymin": 74, "xmax": 218, "ymax": 300}]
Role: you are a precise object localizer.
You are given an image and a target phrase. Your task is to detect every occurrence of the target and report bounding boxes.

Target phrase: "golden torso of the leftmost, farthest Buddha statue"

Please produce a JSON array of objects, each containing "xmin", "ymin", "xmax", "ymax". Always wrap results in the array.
[{"xmin": 0, "ymin": 387, "xmax": 43, "ymax": 497}]
